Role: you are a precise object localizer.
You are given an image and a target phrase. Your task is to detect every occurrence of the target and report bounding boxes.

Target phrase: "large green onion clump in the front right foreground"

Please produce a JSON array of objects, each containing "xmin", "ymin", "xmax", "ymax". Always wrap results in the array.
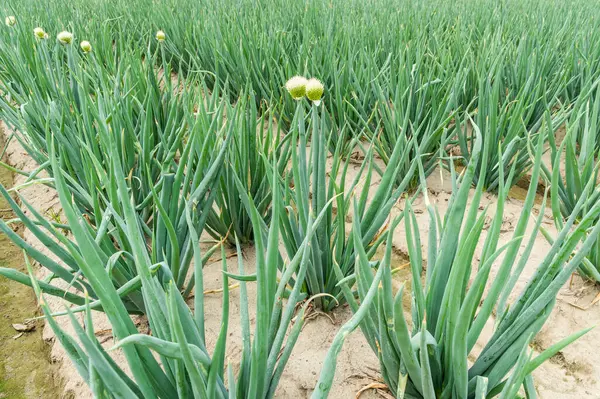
[{"xmin": 312, "ymin": 125, "xmax": 600, "ymax": 399}]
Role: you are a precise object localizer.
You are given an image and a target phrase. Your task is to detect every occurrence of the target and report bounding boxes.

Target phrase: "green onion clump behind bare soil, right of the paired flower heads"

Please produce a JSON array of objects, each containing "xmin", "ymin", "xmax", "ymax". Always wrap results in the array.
[{"xmin": 364, "ymin": 50, "xmax": 462, "ymax": 188}]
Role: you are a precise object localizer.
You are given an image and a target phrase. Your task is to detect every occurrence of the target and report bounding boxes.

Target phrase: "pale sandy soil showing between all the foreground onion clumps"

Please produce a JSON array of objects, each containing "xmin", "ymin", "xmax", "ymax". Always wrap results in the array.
[{"xmin": 1, "ymin": 120, "xmax": 600, "ymax": 399}]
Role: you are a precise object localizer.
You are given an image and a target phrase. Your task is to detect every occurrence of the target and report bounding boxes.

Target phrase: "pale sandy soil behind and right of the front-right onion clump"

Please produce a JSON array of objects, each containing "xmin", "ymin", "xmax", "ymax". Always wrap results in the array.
[{"xmin": 406, "ymin": 168, "xmax": 600, "ymax": 399}]
